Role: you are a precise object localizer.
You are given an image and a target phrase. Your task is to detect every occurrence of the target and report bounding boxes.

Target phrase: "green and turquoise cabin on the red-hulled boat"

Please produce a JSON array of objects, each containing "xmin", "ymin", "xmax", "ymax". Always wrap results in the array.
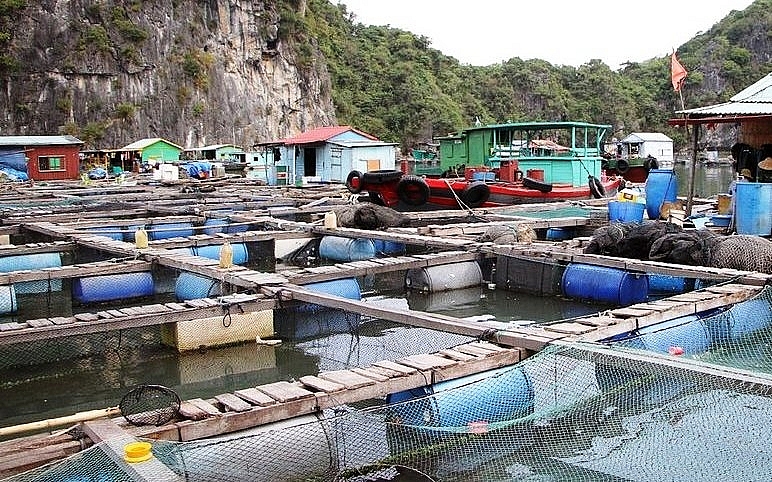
[{"xmin": 439, "ymin": 122, "xmax": 611, "ymax": 186}]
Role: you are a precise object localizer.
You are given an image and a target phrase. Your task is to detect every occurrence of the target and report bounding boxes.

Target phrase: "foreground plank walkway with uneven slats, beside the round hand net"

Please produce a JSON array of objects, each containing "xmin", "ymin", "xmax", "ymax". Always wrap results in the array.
[{"xmin": 128, "ymin": 342, "xmax": 525, "ymax": 441}]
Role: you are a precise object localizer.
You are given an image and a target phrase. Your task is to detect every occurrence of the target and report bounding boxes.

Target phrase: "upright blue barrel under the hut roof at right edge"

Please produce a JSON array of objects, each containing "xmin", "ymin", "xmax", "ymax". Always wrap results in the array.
[{"xmin": 734, "ymin": 182, "xmax": 772, "ymax": 236}]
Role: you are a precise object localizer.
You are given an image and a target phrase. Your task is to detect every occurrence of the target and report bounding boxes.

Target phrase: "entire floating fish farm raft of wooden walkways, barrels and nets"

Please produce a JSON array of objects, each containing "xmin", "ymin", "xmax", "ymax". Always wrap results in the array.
[{"xmin": 0, "ymin": 178, "xmax": 772, "ymax": 481}]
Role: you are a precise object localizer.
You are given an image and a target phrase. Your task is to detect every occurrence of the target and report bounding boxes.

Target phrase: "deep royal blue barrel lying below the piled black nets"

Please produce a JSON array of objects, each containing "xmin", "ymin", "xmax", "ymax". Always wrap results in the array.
[{"xmin": 562, "ymin": 263, "xmax": 649, "ymax": 306}]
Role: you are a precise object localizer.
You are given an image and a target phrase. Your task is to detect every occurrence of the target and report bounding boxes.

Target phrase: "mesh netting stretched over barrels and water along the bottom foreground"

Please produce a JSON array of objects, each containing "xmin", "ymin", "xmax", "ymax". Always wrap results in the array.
[{"xmin": 9, "ymin": 289, "xmax": 772, "ymax": 482}]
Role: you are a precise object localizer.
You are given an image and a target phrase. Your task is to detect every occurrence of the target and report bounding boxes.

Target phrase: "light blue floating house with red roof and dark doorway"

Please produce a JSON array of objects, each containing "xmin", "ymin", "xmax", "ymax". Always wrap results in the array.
[{"xmin": 274, "ymin": 126, "xmax": 397, "ymax": 183}]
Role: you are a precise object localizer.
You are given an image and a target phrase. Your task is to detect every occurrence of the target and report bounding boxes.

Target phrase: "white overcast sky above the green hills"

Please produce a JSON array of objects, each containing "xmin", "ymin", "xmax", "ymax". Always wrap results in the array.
[{"xmin": 338, "ymin": 0, "xmax": 753, "ymax": 70}]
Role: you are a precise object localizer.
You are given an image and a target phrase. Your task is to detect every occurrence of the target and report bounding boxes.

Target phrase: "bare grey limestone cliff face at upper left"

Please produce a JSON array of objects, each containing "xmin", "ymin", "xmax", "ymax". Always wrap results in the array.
[{"xmin": 0, "ymin": 0, "xmax": 335, "ymax": 148}]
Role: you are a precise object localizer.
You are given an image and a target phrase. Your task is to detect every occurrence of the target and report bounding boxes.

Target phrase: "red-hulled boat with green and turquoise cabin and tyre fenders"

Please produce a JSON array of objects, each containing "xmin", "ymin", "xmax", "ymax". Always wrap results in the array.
[{"xmin": 346, "ymin": 122, "xmax": 623, "ymax": 208}]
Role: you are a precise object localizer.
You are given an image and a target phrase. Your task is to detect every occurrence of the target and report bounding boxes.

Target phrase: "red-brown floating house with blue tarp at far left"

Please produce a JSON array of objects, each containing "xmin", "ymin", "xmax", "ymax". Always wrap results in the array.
[{"xmin": 0, "ymin": 136, "xmax": 83, "ymax": 181}]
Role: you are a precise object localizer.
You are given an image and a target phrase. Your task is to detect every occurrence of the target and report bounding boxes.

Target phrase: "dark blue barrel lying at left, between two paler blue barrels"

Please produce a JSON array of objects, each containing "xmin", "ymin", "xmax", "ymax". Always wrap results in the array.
[{"xmin": 72, "ymin": 272, "xmax": 153, "ymax": 303}]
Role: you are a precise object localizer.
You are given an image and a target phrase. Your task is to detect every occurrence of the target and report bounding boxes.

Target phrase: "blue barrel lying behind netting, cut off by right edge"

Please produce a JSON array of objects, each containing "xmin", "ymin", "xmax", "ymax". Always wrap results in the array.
[{"xmin": 708, "ymin": 299, "xmax": 772, "ymax": 343}]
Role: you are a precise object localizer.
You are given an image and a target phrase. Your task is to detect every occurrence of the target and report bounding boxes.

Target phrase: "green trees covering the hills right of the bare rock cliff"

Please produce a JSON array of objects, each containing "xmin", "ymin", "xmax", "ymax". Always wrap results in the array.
[{"xmin": 306, "ymin": 0, "xmax": 772, "ymax": 147}]
